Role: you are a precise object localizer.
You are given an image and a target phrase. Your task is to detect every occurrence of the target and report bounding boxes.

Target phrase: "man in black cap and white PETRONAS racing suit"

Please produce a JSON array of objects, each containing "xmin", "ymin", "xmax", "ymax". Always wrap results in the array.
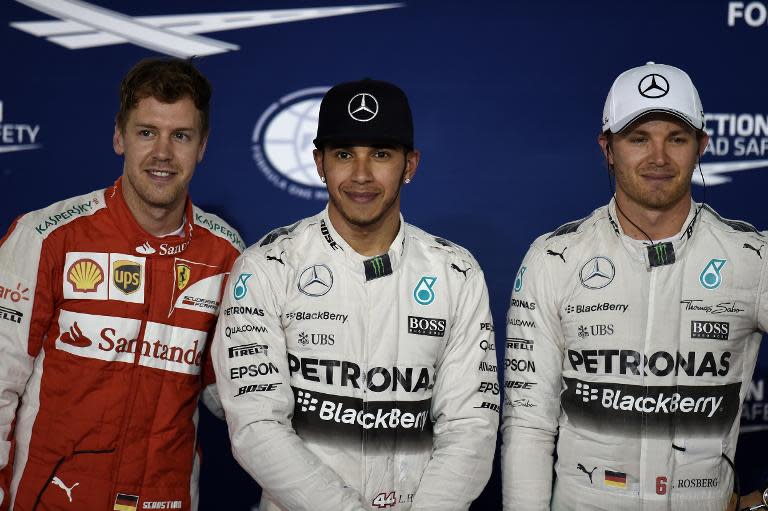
[{"xmin": 213, "ymin": 80, "xmax": 499, "ymax": 511}]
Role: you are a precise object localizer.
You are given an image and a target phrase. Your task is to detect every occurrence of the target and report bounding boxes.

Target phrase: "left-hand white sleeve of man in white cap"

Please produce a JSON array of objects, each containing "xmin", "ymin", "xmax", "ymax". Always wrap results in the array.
[{"xmin": 501, "ymin": 247, "xmax": 563, "ymax": 511}]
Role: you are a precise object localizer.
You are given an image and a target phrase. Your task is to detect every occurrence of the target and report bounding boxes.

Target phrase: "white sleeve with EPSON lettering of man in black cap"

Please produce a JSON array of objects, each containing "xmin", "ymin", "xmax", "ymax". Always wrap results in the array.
[{"xmin": 212, "ymin": 255, "xmax": 366, "ymax": 511}]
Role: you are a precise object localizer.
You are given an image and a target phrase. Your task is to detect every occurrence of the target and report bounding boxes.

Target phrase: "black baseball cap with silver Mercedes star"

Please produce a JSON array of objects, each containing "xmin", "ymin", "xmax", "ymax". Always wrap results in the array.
[{"xmin": 313, "ymin": 78, "xmax": 413, "ymax": 149}]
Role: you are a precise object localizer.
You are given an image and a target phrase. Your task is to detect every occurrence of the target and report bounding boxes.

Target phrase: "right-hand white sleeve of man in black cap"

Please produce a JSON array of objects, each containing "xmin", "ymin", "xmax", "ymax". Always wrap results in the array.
[{"xmin": 412, "ymin": 268, "xmax": 499, "ymax": 511}]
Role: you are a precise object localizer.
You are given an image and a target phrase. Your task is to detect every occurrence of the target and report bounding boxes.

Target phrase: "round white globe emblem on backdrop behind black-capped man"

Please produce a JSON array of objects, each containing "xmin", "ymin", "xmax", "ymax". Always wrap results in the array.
[{"xmin": 251, "ymin": 87, "xmax": 328, "ymax": 201}]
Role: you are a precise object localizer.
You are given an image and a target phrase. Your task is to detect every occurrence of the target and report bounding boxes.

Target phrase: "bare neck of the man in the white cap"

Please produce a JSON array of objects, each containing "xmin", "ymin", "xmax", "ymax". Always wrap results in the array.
[{"xmin": 615, "ymin": 192, "xmax": 691, "ymax": 241}]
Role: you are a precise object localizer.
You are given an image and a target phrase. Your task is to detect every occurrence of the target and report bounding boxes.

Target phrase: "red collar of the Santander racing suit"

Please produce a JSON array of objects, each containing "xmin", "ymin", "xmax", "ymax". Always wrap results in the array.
[{"xmin": 104, "ymin": 177, "xmax": 194, "ymax": 256}]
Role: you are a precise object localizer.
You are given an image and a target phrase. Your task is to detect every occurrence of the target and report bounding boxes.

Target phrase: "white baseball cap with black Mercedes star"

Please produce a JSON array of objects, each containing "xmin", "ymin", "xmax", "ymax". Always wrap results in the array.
[{"xmin": 603, "ymin": 62, "xmax": 704, "ymax": 133}]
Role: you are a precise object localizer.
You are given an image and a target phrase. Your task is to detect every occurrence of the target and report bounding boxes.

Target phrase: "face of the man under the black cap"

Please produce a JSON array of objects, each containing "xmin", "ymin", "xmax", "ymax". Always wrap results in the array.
[{"xmin": 314, "ymin": 146, "xmax": 419, "ymax": 233}]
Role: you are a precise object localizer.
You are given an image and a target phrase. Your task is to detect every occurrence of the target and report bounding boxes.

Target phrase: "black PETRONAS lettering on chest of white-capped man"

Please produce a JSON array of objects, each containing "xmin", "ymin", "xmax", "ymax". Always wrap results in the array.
[{"xmin": 568, "ymin": 349, "xmax": 731, "ymax": 376}]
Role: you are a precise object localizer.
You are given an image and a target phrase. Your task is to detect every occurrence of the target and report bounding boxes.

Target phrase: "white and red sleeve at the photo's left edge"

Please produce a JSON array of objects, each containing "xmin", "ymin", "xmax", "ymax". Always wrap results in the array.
[{"xmin": 0, "ymin": 223, "xmax": 53, "ymax": 511}]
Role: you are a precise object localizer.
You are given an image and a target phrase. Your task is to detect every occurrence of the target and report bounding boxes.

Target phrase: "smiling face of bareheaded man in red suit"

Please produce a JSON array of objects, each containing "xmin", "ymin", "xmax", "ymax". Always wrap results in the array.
[{"xmin": 112, "ymin": 96, "xmax": 207, "ymax": 223}]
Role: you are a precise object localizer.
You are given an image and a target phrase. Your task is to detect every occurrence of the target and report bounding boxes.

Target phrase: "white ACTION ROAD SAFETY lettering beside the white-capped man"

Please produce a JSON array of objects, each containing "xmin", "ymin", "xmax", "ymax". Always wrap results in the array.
[{"xmin": 693, "ymin": 113, "xmax": 768, "ymax": 185}]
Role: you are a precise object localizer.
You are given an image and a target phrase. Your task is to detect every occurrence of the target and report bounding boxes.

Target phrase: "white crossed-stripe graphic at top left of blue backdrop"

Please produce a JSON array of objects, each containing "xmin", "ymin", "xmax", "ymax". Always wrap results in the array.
[{"xmin": 10, "ymin": 0, "xmax": 403, "ymax": 58}]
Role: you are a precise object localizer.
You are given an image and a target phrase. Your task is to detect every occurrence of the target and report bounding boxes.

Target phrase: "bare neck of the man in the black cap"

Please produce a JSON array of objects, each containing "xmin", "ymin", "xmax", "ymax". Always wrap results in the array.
[{"xmin": 328, "ymin": 204, "xmax": 400, "ymax": 257}]
